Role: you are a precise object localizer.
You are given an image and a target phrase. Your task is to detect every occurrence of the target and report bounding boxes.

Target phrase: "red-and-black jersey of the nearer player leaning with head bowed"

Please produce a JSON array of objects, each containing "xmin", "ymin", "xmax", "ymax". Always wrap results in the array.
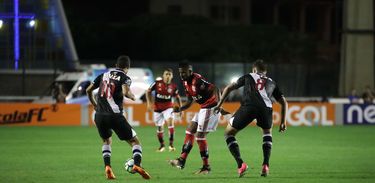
[{"xmin": 183, "ymin": 73, "xmax": 217, "ymax": 108}]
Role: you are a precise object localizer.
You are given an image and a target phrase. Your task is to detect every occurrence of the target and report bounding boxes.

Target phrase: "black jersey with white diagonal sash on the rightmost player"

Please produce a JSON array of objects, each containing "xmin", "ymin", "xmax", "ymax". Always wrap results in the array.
[{"xmin": 234, "ymin": 73, "xmax": 283, "ymax": 108}]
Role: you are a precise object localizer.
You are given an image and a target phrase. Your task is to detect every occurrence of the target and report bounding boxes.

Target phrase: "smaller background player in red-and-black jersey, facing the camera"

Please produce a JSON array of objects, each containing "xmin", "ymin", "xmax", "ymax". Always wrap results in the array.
[{"xmin": 146, "ymin": 68, "xmax": 181, "ymax": 152}]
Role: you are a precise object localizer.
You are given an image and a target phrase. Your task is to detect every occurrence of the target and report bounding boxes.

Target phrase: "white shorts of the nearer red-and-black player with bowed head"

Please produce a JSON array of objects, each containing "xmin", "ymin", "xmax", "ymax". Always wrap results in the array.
[{"xmin": 191, "ymin": 108, "xmax": 220, "ymax": 132}]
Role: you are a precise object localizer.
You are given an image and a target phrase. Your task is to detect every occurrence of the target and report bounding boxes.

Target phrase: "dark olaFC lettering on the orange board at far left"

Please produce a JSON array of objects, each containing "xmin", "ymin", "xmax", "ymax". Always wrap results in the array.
[{"xmin": 0, "ymin": 107, "xmax": 49, "ymax": 125}]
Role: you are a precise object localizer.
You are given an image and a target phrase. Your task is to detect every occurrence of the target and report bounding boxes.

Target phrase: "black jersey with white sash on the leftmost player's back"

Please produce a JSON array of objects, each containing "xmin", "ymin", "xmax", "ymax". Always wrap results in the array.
[{"xmin": 93, "ymin": 69, "xmax": 132, "ymax": 114}]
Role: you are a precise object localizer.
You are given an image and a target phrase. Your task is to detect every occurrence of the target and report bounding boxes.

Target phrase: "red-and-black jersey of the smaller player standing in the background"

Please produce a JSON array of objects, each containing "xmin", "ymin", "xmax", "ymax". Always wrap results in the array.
[{"xmin": 149, "ymin": 80, "xmax": 179, "ymax": 112}]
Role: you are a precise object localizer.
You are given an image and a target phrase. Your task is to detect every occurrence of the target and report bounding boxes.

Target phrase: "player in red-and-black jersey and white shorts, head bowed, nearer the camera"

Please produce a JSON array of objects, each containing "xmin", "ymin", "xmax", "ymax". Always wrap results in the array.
[{"xmin": 169, "ymin": 63, "xmax": 226, "ymax": 174}]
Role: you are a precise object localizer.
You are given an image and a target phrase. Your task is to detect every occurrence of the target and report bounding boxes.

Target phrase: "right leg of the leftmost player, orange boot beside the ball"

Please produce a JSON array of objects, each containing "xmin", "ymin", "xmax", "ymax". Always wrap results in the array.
[{"xmin": 112, "ymin": 115, "xmax": 150, "ymax": 179}]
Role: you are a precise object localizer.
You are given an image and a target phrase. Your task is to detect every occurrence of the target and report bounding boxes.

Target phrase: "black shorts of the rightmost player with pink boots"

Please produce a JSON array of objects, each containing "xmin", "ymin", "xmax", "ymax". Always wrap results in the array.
[{"xmin": 230, "ymin": 106, "xmax": 272, "ymax": 130}]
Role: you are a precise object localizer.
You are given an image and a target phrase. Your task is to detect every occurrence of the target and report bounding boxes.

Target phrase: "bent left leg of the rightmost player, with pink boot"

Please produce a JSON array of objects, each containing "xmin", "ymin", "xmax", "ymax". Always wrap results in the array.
[{"xmin": 224, "ymin": 106, "xmax": 255, "ymax": 177}]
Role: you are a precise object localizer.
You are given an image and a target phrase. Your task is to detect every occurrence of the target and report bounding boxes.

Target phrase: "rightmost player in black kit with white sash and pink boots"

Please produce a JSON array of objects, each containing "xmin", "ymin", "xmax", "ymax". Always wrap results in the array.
[{"xmin": 214, "ymin": 60, "xmax": 288, "ymax": 177}]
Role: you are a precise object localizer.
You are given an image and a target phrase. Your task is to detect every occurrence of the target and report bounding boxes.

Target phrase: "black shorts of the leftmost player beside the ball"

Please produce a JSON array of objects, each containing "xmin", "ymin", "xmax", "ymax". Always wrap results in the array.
[{"xmin": 95, "ymin": 113, "xmax": 137, "ymax": 140}]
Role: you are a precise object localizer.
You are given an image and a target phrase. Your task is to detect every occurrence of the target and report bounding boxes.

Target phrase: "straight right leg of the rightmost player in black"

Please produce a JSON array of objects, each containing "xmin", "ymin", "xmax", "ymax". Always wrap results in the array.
[{"xmin": 257, "ymin": 108, "xmax": 272, "ymax": 177}]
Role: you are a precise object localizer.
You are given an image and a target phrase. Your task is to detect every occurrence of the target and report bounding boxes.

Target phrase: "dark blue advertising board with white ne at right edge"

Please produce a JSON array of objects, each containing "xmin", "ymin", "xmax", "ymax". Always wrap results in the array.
[{"xmin": 344, "ymin": 104, "xmax": 375, "ymax": 125}]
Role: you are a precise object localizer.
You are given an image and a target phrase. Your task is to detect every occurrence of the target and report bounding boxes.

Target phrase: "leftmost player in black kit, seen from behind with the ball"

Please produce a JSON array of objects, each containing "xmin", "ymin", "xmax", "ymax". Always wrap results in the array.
[{"xmin": 86, "ymin": 56, "xmax": 150, "ymax": 179}]
